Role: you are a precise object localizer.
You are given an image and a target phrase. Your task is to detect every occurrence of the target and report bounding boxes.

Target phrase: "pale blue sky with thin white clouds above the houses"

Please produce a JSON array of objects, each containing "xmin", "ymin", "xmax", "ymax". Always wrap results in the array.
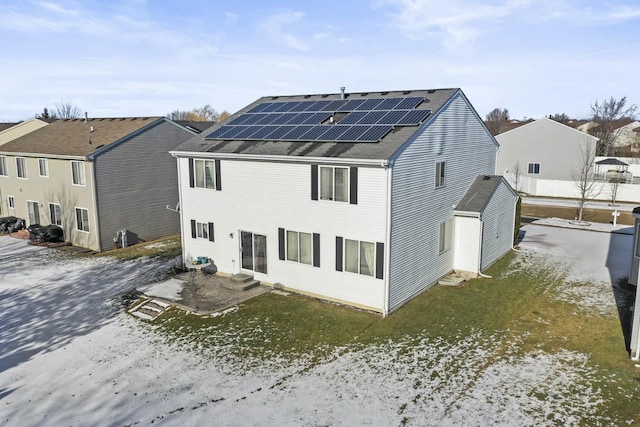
[{"xmin": 0, "ymin": 0, "xmax": 640, "ymax": 121}]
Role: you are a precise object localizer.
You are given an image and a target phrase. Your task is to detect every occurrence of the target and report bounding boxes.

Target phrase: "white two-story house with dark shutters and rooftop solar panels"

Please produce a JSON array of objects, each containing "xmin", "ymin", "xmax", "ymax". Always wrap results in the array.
[{"xmin": 172, "ymin": 89, "xmax": 516, "ymax": 315}]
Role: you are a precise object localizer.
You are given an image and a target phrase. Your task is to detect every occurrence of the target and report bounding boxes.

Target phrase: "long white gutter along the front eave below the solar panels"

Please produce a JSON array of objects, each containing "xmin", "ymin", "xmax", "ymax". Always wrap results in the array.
[{"xmin": 169, "ymin": 151, "xmax": 389, "ymax": 168}]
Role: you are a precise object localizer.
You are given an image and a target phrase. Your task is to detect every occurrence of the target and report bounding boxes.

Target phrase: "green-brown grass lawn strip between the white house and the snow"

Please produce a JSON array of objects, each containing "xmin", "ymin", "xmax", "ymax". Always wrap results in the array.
[{"xmin": 141, "ymin": 254, "xmax": 640, "ymax": 424}]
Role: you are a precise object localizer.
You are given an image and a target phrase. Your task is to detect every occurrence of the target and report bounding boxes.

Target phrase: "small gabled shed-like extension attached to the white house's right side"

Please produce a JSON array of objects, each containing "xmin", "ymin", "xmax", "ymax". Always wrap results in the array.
[{"xmin": 453, "ymin": 175, "xmax": 518, "ymax": 274}]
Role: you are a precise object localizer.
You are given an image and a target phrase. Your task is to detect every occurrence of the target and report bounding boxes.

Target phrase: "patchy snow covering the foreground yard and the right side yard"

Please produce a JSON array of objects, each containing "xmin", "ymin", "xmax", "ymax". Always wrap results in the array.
[{"xmin": 0, "ymin": 229, "xmax": 631, "ymax": 426}]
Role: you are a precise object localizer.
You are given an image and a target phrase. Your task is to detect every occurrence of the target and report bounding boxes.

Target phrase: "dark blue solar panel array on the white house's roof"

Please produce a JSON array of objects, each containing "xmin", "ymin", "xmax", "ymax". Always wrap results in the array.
[{"xmin": 205, "ymin": 97, "xmax": 431, "ymax": 142}]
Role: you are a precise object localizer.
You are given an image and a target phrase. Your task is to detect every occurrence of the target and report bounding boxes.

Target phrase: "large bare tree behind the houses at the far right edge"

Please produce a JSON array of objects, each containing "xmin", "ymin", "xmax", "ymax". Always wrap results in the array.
[{"xmin": 591, "ymin": 96, "xmax": 638, "ymax": 156}]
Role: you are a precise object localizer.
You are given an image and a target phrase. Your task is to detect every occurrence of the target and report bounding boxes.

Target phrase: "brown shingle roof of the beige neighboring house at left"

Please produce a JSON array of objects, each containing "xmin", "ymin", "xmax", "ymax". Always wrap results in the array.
[{"xmin": 0, "ymin": 117, "xmax": 166, "ymax": 156}]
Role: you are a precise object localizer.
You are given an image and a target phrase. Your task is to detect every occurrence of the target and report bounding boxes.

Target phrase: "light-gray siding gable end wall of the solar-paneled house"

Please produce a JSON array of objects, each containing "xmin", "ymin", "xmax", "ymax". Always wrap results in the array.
[{"xmin": 389, "ymin": 95, "xmax": 498, "ymax": 310}]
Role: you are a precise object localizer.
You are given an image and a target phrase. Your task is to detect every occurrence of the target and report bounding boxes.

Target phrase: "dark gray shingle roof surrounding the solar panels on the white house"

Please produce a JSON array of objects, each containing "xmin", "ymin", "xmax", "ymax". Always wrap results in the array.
[{"xmin": 175, "ymin": 88, "xmax": 459, "ymax": 160}]
